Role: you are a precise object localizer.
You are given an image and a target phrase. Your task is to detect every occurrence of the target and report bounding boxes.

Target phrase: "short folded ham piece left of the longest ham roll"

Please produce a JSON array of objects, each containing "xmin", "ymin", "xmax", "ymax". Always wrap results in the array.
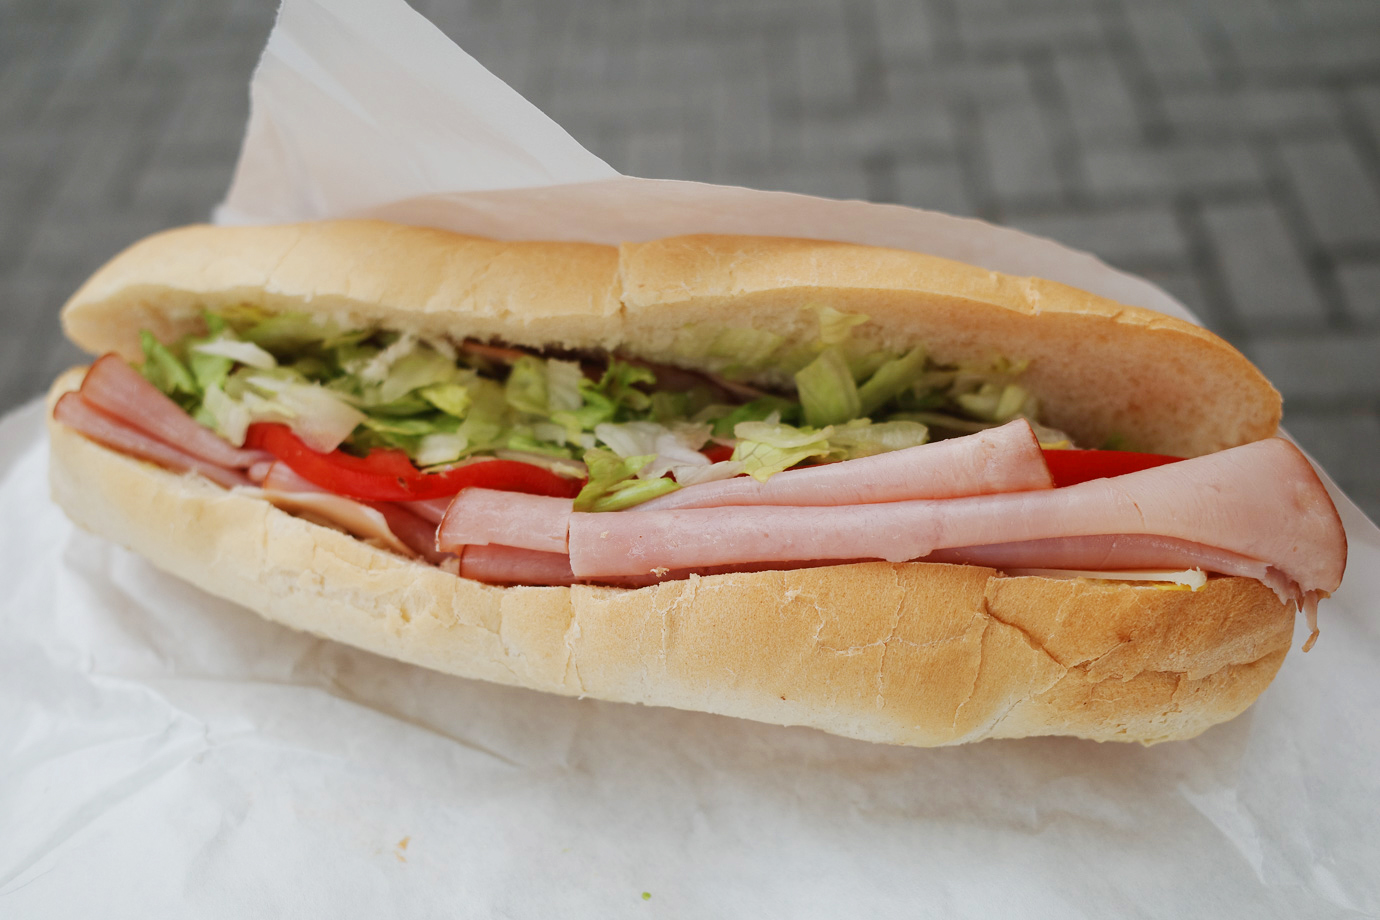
[{"xmin": 436, "ymin": 488, "xmax": 574, "ymax": 554}]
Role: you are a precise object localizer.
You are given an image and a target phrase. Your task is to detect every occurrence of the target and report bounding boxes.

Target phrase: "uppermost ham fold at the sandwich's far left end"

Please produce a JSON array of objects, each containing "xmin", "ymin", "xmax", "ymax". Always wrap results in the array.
[{"xmin": 80, "ymin": 354, "xmax": 269, "ymax": 469}]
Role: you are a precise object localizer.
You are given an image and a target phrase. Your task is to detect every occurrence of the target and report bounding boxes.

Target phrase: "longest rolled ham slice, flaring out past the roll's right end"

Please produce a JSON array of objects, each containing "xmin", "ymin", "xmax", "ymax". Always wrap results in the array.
[{"xmin": 563, "ymin": 439, "xmax": 1346, "ymax": 604}]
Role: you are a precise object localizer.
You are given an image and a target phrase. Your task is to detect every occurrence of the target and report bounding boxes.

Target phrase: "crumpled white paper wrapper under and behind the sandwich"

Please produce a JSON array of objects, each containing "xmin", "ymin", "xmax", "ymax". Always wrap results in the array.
[{"xmin": 0, "ymin": 0, "xmax": 1380, "ymax": 919}]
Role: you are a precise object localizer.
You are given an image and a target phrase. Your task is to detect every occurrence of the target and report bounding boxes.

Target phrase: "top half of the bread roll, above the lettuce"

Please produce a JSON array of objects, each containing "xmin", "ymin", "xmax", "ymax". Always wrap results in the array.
[{"xmin": 62, "ymin": 221, "xmax": 1281, "ymax": 457}]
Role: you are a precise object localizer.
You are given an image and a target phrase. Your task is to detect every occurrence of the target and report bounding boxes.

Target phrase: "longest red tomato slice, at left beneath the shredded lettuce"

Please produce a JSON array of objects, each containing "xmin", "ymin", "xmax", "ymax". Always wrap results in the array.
[{"xmin": 246, "ymin": 422, "xmax": 584, "ymax": 502}]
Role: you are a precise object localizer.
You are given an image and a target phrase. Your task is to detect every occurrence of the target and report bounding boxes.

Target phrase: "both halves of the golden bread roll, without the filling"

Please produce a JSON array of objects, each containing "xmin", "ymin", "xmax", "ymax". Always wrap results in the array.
[{"xmin": 43, "ymin": 222, "xmax": 1293, "ymax": 745}]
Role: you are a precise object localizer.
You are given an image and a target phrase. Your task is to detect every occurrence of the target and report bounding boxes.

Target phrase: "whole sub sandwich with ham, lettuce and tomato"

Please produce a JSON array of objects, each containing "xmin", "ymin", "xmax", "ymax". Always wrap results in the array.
[{"xmin": 50, "ymin": 221, "xmax": 1346, "ymax": 746}]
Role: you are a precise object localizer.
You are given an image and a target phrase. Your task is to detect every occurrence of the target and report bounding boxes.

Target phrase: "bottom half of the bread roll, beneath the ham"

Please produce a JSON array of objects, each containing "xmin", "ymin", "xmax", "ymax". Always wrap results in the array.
[{"xmin": 50, "ymin": 378, "xmax": 1293, "ymax": 746}]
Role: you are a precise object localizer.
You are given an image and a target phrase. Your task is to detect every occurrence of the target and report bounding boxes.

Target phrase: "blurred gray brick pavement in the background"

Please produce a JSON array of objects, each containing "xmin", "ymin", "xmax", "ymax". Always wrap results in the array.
[{"xmin": 0, "ymin": 0, "xmax": 1380, "ymax": 519}]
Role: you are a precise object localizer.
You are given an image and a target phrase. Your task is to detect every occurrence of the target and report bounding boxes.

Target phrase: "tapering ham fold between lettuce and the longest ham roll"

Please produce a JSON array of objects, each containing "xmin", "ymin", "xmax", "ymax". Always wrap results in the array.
[{"xmin": 631, "ymin": 419, "xmax": 1054, "ymax": 512}]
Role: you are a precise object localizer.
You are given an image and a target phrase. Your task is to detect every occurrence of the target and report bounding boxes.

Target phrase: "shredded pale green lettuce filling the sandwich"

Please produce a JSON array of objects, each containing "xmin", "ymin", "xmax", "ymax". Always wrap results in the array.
[{"xmin": 129, "ymin": 303, "xmax": 1054, "ymax": 510}]
